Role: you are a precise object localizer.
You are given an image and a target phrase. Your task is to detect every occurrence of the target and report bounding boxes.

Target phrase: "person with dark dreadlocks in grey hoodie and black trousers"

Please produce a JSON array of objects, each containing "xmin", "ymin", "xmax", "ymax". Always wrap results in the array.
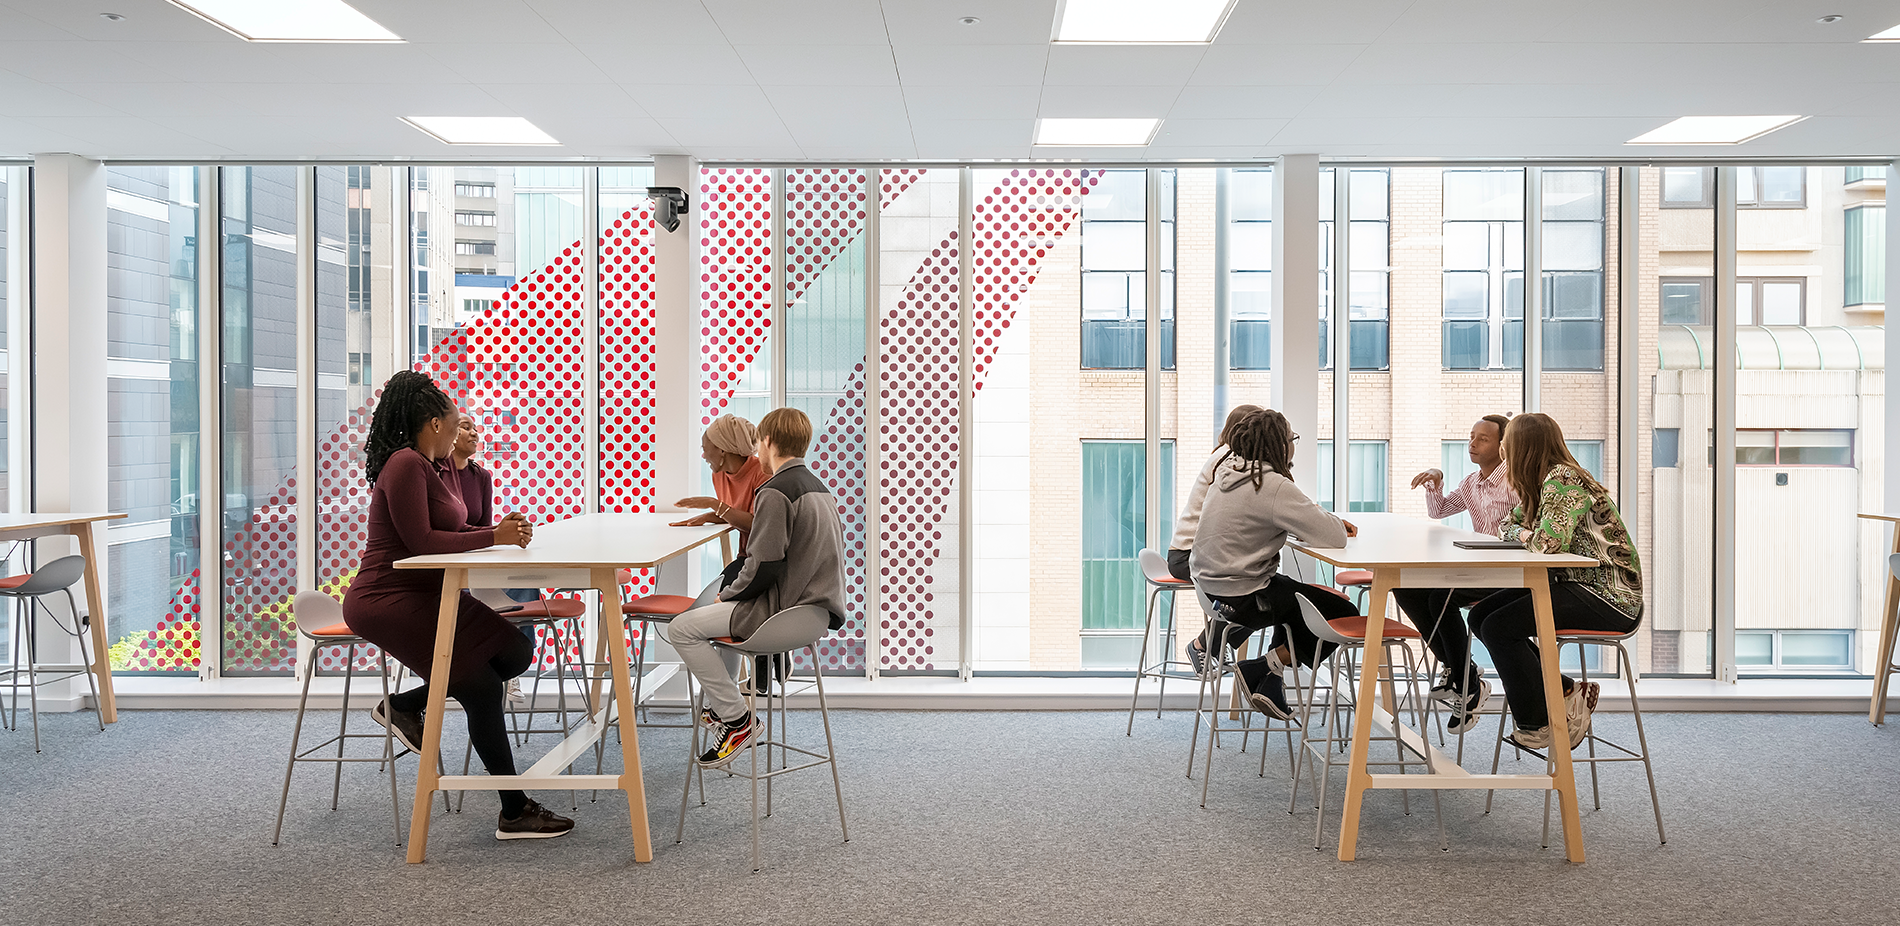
[{"xmin": 1188, "ymin": 409, "xmax": 1359, "ymax": 721}]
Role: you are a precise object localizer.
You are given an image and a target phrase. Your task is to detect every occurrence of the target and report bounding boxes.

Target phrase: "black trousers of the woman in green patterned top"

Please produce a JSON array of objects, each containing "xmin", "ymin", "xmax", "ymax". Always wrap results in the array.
[{"xmin": 1471, "ymin": 582, "xmax": 1636, "ymax": 730}]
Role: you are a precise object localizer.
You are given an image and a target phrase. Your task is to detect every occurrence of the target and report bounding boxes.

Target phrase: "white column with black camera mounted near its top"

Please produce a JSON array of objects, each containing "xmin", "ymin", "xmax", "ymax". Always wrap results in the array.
[{"xmin": 654, "ymin": 154, "xmax": 705, "ymax": 595}]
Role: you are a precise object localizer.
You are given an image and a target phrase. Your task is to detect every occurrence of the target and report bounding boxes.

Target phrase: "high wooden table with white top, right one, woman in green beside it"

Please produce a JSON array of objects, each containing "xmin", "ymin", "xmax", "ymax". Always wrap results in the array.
[{"xmin": 1288, "ymin": 513, "xmax": 1598, "ymax": 863}]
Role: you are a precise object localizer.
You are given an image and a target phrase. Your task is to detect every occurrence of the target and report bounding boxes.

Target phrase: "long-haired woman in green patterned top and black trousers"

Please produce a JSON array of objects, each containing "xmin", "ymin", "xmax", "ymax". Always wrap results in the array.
[{"xmin": 1471, "ymin": 413, "xmax": 1644, "ymax": 749}]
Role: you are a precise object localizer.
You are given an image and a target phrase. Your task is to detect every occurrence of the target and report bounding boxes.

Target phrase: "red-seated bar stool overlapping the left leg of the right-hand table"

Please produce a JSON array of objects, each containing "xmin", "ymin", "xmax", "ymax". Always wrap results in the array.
[{"xmin": 1286, "ymin": 595, "xmax": 1446, "ymax": 848}]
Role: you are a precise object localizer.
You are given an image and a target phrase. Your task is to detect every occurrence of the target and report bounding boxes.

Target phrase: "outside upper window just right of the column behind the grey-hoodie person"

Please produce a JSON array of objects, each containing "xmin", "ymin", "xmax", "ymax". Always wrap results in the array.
[{"xmin": 1319, "ymin": 167, "xmax": 1393, "ymax": 369}]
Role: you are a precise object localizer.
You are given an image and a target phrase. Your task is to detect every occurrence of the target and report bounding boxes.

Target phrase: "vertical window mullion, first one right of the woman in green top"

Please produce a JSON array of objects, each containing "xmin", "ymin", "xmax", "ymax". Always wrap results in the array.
[{"xmin": 1691, "ymin": 167, "xmax": 1737, "ymax": 683}]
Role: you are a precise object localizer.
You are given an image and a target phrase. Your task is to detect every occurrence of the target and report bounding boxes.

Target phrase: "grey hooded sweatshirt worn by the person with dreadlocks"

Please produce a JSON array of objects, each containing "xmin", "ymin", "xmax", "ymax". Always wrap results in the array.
[{"xmin": 1189, "ymin": 456, "xmax": 1345, "ymax": 597}]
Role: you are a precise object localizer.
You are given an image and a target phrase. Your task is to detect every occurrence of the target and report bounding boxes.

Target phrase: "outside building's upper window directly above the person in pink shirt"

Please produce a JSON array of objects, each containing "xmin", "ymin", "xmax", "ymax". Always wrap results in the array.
[{"xmin": 1442, "ymin": 169, "xmax": 1524, "ymax": 371}]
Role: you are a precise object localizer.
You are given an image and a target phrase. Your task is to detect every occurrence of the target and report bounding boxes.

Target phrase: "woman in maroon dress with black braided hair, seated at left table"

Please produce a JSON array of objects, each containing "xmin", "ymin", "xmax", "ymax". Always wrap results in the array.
[{"xmin": 344, "ymin": 371, "xmax": 574, "ymax": 839}]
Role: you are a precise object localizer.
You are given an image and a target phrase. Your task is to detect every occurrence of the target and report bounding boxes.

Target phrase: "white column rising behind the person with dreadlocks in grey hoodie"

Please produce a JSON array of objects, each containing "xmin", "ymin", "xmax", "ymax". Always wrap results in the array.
[{"xmin": 1276, "ymin": 154, "xmax": 1319, "ymax": 496}]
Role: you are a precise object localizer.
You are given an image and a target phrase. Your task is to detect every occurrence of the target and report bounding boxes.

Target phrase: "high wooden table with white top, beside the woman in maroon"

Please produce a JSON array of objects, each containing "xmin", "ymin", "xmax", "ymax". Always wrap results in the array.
[{"xmin": 395, "ymin": 513, "xmax": 732, "ymax": 863}]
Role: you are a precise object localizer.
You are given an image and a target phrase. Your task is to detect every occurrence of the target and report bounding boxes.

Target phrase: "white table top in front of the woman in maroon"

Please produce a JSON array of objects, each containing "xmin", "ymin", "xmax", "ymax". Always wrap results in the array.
[{"xmin": 395, "ymin": 511, "xmax": 732, "ymax": 569}]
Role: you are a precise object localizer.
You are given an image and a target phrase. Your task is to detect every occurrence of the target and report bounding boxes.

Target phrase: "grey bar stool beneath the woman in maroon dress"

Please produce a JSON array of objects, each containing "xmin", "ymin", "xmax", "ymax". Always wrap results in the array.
[{"xmin": 270, "ymin": 591, "xmax": 406, "ymax": 846}]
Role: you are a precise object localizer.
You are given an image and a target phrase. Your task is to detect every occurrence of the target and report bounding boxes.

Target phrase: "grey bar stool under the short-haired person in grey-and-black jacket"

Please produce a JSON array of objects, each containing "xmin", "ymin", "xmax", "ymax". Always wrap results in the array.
[{"xmin": 673, "ymin": 605, "xmax": 851, "ymax": 871}]
